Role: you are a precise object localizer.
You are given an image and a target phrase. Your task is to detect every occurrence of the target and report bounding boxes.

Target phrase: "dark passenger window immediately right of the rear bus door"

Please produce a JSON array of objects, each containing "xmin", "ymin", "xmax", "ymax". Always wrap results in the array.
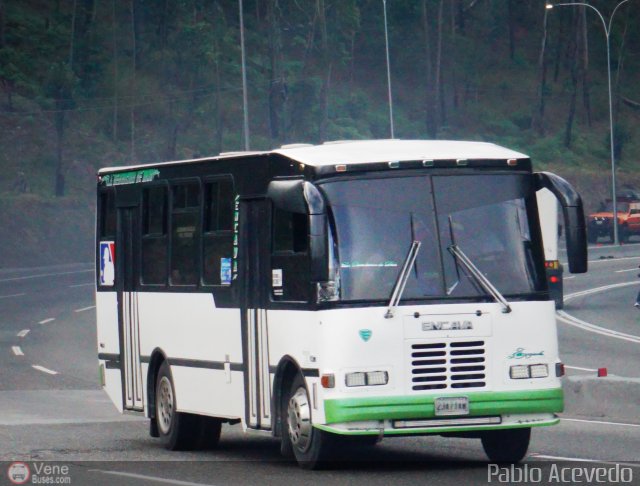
[{"xmin": 141, "ymin": 186, "xmax": 167, "ymax": 285}]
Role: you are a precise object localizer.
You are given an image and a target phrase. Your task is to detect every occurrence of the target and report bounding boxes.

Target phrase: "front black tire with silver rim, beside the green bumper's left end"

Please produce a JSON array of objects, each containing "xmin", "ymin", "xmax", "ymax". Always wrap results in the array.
[{"xmin": 281, "ymin": 375, "xmax": 335, "ymax": 469}]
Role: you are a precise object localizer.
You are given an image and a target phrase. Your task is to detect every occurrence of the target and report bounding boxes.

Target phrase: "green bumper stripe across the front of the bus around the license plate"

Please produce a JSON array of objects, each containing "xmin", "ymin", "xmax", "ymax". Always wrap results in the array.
[{"xmin": 324, "ymin": 388, "xmax": 564, "ymax": 424}]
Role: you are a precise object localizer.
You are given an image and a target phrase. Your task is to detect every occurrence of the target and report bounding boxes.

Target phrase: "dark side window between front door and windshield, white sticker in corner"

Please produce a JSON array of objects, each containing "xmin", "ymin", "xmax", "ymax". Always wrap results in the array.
[{"xmin": 271, "ymin": 208, "xmax": 311, "ymax": 302}]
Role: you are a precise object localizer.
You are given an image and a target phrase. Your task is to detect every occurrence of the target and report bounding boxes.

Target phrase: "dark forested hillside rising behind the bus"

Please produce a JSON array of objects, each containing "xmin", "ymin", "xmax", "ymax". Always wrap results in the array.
[{"xmin": 0, "ymin": 0, "xmax": 640, "ymax": 266}]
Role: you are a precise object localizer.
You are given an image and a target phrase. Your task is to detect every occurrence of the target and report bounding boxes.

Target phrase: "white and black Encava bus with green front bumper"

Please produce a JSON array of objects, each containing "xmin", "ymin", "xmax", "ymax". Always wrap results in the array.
[{"xmin": 96, "ymin": 140, "xmax": 587, "ymax": 468}]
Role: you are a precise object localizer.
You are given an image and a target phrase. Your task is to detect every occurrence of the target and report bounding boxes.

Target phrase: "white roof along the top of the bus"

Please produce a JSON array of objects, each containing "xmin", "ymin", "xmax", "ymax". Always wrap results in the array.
[{"xmin": 98, "ymin": 139, "xmax": 529, "ymax": 174}]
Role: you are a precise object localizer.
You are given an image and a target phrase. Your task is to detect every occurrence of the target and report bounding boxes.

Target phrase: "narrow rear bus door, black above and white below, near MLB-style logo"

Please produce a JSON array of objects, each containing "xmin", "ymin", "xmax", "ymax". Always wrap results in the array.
[{"xmin": 115, "ymin": 201, "xmax": 144, "ymax": 411}]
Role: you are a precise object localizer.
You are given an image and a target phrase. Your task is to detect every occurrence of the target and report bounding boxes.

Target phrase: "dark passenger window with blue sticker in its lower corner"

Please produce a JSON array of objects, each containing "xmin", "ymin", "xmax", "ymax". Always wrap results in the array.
[{"xmin": 203, "ymin": 178, "xmax": 234, "ymax": 285}]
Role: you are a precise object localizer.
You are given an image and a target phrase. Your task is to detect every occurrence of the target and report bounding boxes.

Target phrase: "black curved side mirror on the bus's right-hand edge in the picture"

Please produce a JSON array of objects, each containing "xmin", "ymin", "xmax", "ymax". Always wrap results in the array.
[{"xmin": 534, "ymin": 172, "xmax": 588, "ymax": 273}]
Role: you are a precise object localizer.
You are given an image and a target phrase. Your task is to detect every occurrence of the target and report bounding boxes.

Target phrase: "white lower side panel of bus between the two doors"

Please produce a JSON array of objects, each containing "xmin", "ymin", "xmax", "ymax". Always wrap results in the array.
[{"xmin": 139, "ymin": 292, "xmax": 244, "ymax": 417}]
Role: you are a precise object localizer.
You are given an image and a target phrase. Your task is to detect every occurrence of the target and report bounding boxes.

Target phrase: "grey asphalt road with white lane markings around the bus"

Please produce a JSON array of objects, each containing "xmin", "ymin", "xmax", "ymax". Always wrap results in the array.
[{"xmin": 0, "ymin": 256, "xmax": 640, "ymax": 486}]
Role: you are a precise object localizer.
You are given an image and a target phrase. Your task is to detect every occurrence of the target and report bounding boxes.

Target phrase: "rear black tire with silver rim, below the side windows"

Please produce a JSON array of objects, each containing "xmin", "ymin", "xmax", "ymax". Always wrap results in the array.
[{"xmin": 155, "ymin": 361, "xmax": 200, "ymax": 451}]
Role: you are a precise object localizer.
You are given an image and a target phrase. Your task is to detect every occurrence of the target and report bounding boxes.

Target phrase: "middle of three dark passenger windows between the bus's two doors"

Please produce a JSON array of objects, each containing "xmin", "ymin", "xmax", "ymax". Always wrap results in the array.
[{"xmin": 170, "ymin": 182, "xmax": 200, "ymax": 285}]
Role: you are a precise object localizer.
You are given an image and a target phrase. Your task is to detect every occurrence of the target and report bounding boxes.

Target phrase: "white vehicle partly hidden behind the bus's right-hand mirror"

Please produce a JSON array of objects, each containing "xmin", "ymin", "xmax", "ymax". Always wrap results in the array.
[{"xmin": 536, "ymin": 188, "xmax": 564, "ymax": 309}]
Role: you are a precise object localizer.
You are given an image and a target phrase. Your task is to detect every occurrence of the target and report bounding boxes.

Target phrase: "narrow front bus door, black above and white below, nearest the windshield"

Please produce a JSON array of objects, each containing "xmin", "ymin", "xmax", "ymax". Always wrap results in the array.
[{"xmin": 239, "ymin": 199, "xmax": 271, "ymax": 429}]
